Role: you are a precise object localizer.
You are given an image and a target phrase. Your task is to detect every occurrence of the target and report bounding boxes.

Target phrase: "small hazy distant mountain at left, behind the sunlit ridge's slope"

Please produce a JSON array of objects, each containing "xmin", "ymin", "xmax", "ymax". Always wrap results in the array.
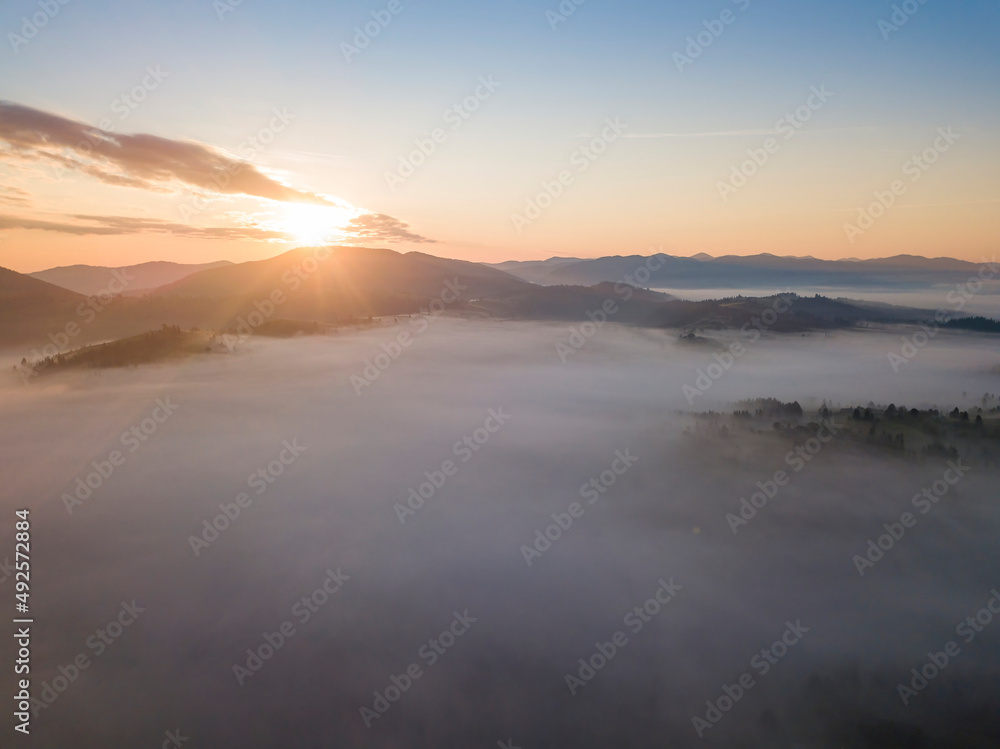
[{"xmin": 28, "ymin": 260, "xmax": 232, "ymax": 296}]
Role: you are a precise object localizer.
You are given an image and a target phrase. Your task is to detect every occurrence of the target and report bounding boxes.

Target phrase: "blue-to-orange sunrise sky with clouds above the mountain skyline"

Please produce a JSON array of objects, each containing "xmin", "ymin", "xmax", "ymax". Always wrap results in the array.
[{"xmin": 0, "ymin": 0, "xmax": 1000, "ymax": 272}]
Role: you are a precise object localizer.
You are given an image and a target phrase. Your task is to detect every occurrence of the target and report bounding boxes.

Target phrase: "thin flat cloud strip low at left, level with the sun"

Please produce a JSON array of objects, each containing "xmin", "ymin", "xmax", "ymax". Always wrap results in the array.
[{"xmin": 0, "ymin": 214, "xmax": 288, "ymax": 241}]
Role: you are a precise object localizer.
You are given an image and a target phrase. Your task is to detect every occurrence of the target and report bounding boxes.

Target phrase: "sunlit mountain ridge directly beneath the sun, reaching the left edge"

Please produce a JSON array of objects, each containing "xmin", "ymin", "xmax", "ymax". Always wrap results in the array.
[{"xmin": 0, "ymin": 247, "xmax": 530, "ymax": 356}]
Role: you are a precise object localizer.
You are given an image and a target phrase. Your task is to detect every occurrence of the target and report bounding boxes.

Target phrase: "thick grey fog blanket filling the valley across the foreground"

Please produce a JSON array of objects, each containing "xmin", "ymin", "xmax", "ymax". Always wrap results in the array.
[{"xmin": 0, "ymin": 319, "xmax": 1000, "ymax": 749}]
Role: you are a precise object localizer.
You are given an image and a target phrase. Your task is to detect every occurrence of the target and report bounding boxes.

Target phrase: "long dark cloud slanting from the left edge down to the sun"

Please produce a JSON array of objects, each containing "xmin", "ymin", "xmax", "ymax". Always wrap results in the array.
[{"xmin": 0, "ymin": 101, "xmax": 329, "ymax": 205}]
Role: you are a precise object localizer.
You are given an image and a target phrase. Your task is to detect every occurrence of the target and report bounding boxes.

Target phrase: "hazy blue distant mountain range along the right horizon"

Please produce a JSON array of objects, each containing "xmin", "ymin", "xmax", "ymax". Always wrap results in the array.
[{"xmin": 493, "ymin": 253, "xmax": 980, "ymax": 291}]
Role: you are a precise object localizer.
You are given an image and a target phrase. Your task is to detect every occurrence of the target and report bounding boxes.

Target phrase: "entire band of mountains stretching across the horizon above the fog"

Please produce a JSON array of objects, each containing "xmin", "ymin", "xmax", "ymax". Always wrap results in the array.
[{"xmin": 0, "ymin": 247, "xmax": 992, "ymax": 351}]
